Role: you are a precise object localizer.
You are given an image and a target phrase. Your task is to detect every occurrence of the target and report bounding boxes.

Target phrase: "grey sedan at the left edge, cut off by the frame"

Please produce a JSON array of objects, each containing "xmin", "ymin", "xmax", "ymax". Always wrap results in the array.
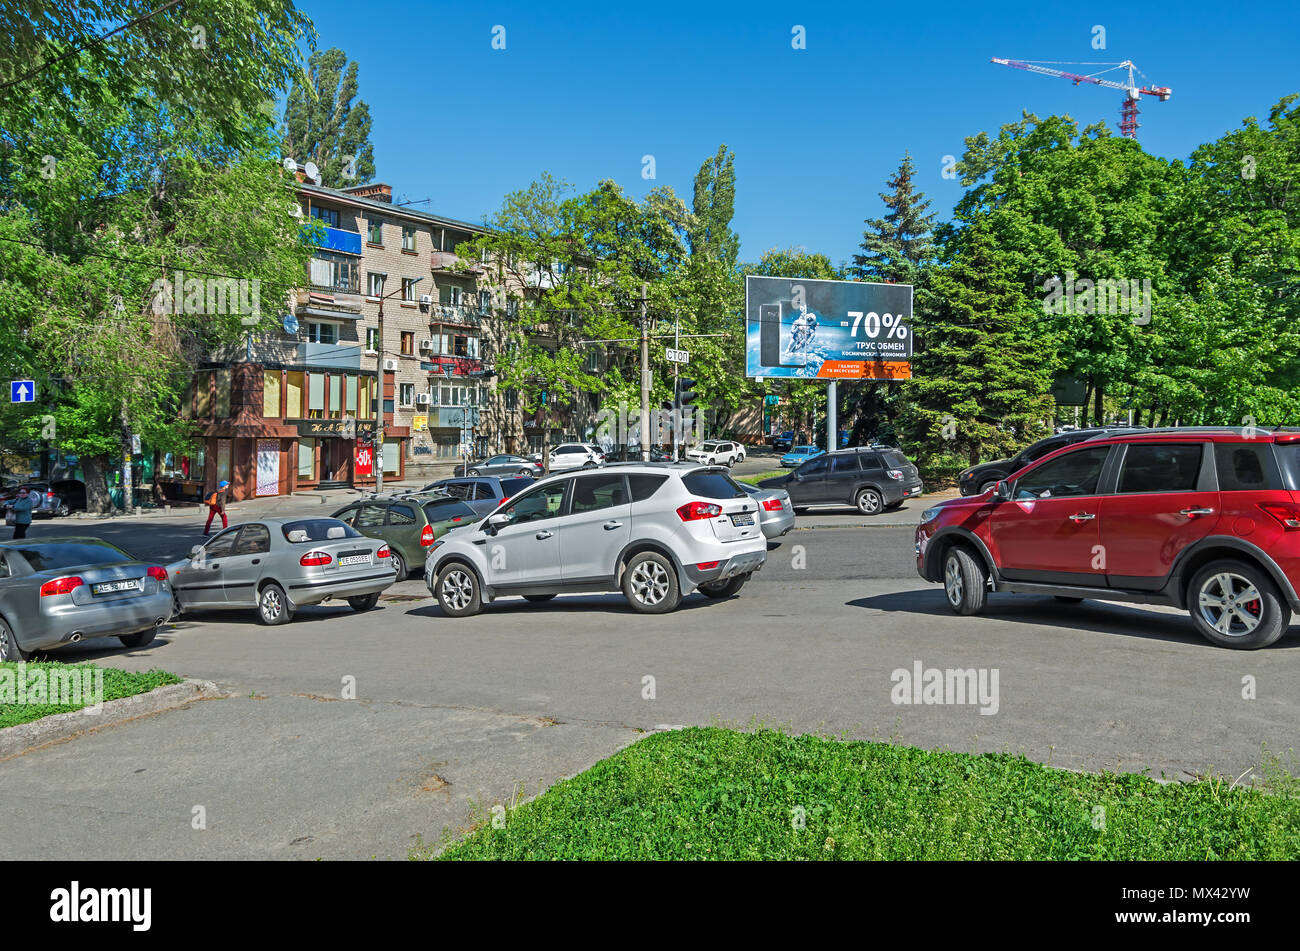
[{"xmin": 0, "ymin": 537, "xmax": 172, "ymax": 661}]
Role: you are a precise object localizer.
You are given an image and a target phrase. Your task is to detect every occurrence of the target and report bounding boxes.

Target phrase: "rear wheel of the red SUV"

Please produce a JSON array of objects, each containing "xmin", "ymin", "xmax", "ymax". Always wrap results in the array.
[{"xmin": 1187, "ymin": 559, "xmax": 1291, "ymax": 651}]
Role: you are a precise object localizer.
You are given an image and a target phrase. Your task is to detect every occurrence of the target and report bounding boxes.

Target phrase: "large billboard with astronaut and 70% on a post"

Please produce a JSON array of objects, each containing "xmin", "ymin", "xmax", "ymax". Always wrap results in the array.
[{"xmin": 745, "ymin": 274, "xmax": 911, "ymax": 379}]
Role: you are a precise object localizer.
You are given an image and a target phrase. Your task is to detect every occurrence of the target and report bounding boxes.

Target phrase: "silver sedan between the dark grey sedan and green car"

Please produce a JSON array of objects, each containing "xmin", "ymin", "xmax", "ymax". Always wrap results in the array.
[{"xmin": 166, "ymin": 518, "xmax": 397, "ymax": 624}]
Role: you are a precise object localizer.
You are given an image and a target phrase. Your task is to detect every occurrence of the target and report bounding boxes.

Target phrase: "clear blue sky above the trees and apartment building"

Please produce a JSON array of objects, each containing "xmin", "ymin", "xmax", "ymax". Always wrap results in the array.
[{"xmin": 300, "ymin": 0, "xmax": 1300, "ymax": 261}]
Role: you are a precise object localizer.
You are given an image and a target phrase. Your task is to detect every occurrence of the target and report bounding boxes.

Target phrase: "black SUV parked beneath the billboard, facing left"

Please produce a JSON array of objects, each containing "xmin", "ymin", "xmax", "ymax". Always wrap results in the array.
[{"xmin": 758, "ymin": 446, "xmax": 924, "ymax": 514}]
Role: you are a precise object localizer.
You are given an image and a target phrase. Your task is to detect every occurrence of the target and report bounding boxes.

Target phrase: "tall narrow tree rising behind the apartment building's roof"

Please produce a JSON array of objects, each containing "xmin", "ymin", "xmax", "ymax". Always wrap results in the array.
[{"xmin": 282, "ymin": 47, "xmax": 374, "ymax": 188}]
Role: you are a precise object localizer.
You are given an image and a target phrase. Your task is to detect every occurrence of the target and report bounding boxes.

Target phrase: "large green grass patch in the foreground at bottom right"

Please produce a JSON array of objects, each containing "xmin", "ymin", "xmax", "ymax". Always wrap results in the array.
[{"xmin": 428, "ymin": 728, "xmax": 1300, "ymax": 860}]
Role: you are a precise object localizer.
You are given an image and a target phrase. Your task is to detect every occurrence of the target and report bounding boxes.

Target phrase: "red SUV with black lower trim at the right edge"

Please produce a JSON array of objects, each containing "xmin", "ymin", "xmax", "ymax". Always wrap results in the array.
[{"xmin": 917, "ymin": 427, "xmax": 1300, "ymax": 650}]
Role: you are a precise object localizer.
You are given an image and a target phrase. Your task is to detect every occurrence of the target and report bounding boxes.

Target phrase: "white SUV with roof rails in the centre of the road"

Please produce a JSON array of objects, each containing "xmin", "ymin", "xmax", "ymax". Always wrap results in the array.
[{"xmin": 424, "ymin": 463, "xmax": 767, "ymax": 617}]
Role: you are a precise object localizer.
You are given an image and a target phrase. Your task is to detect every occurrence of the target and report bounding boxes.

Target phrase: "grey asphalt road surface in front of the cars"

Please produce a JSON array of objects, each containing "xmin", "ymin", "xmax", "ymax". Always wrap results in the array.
[{"xmin": 0, "ymin": 511, "xmax": 1300, "ymax": 859}]
